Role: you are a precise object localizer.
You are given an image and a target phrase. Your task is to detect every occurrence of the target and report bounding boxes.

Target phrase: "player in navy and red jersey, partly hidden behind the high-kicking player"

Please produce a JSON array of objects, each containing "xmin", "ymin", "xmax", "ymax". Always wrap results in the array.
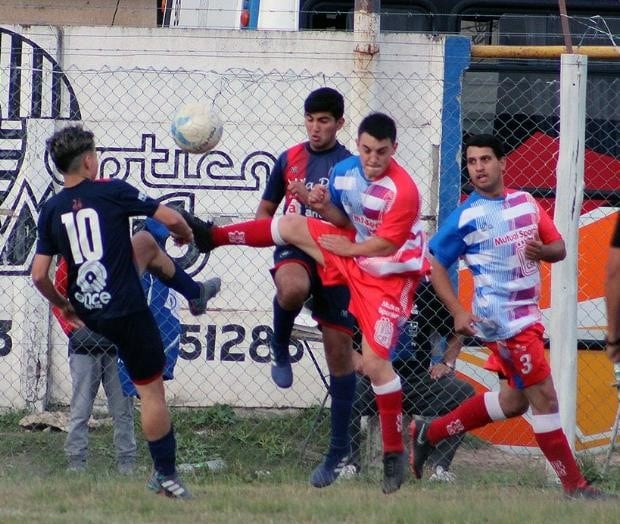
[{"xmin": 256, "ymin": 87, "xmax": 355, "ymax": 487}]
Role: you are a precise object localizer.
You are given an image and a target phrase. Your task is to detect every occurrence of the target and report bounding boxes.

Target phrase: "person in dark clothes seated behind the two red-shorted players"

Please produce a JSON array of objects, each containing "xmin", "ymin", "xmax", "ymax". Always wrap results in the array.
[{"xmin": 348, "ymin": 280, "xmax": 474, "ymax": 482}]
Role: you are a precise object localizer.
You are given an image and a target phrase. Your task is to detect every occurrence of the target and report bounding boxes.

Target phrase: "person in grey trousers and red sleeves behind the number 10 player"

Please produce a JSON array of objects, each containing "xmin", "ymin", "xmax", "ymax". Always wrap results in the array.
[{"xmin": 52, "ymin": 258, "xmax": 137, "ymax": 475}]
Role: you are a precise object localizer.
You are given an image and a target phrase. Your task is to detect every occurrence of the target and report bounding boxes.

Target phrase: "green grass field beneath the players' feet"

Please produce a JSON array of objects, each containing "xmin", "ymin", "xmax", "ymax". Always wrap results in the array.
[{"xmin": 0, "ymin": 406, "xmax": 620, "ymax": 524}]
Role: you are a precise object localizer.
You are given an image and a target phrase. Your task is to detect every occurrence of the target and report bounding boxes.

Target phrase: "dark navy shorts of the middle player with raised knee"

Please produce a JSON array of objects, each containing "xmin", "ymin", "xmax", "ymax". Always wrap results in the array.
[{"xmin": 271, "ymin": 245, "xmax": 355, "ymax": 334}]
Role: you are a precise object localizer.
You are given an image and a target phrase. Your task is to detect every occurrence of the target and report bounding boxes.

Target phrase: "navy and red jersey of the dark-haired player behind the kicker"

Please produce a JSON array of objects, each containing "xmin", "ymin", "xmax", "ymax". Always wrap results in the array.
[{"xmin": 263, "ymin": 142, "xmax": 351, "ymax": 216}]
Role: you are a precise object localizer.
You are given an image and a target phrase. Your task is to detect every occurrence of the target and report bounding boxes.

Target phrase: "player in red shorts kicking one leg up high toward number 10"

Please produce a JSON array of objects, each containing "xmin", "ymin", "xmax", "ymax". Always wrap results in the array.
[{"xmin": 182, "ymin": 113, "xmax": 428, "ymax": 493}]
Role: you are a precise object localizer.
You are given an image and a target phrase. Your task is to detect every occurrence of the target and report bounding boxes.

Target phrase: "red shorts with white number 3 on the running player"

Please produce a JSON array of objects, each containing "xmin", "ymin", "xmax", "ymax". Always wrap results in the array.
[{"xmin": 484, "ymin": 323, "xmax": 551, "ymax": 389}]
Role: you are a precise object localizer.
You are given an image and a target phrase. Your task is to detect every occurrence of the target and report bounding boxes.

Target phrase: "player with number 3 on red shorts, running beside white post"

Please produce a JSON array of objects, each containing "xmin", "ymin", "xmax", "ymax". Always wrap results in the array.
[{"xmin": 409, "ymin": 135, "xmax": 610, "ymax": 499}]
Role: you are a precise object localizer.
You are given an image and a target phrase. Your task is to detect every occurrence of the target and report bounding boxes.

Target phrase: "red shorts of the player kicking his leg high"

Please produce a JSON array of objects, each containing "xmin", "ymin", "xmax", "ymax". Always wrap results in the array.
[{"xmin": 307, "ymin": 218, "xmax": 418, "ymax": 360}]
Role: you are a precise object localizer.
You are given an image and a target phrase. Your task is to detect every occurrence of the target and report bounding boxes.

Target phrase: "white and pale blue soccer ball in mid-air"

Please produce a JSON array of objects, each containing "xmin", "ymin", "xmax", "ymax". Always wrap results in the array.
[{"xmin": 170, "ymin": 102, "xmax": 224, "ymax": 154}]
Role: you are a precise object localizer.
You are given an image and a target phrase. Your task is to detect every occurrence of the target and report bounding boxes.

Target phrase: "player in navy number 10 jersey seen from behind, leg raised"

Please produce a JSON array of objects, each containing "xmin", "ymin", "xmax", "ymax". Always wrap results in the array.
[{"xmin": 32, "ymin": 126, "xmax": 220, "ymax": 498}]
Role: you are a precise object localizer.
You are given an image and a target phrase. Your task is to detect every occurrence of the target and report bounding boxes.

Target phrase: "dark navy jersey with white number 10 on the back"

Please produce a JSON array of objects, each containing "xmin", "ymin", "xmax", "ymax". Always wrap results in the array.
[{"xmin": 36, "ymin": 180, "xmax": 159, "ymax": 323}]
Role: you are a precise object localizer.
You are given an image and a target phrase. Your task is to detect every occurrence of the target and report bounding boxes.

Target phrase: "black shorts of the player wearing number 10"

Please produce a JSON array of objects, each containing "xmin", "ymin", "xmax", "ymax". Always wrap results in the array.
[{"xmin": 88, "ymin": 309, "xmax": 166, "ymax": 384}]
